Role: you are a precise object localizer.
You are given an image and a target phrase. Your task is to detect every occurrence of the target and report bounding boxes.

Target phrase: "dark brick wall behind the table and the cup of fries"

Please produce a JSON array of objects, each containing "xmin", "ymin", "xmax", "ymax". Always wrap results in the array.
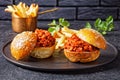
[{"xmin": 0, "ymin": 0, "xmax": 120, "ymax": 20}]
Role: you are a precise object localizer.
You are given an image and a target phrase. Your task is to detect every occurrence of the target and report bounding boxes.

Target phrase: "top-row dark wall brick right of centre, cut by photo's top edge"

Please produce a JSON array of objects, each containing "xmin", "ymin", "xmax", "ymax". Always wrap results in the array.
[{"xmin": 58, "ymin": 0, "xmax": 99, "ymax": 6}]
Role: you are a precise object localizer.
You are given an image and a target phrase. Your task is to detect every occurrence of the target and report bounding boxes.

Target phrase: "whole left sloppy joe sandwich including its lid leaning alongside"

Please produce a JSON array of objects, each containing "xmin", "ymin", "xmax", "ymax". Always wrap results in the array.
[{"xmin": 10, "ymin": 29, "xmax": 55, "ymax": 60}]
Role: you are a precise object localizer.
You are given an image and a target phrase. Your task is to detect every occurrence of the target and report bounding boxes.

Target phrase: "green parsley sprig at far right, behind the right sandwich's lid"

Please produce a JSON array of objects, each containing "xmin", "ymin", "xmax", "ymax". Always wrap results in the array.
[{"xmin": 85, "ymin": 16, "xmax": 114, "ymax": 35}]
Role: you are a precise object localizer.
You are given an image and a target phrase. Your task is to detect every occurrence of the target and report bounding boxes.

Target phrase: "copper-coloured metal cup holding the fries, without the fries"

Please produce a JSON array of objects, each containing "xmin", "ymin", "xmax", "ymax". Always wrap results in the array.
[{"xmin": 12, "ymin": 15, "xmax": 37, "ymax": 33}]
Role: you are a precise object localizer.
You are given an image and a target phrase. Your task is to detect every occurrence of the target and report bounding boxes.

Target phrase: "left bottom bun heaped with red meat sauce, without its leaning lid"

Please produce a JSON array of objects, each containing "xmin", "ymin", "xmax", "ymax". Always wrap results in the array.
[{"xmin": 30, "ymin": 29, "xmax": 55, "ymax": 58}]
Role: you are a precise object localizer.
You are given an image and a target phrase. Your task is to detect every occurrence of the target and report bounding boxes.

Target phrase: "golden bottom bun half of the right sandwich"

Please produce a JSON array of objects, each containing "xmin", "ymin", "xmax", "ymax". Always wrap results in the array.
[{"xmin": 64, "ymin": 49, "xmax": 100, "ymax": 63}]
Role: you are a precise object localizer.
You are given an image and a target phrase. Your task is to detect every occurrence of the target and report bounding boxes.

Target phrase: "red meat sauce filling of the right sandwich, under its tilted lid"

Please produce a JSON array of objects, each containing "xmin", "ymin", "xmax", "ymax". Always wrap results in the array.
[{"xmin": 64, "ymin": 34, "xmax": 98, "ymax": 52}]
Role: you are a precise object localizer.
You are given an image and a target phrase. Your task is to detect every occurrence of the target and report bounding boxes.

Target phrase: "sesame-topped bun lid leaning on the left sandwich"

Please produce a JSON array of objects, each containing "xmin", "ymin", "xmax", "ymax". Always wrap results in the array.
[{"xmin": 10, "ymin": 31, "xmax": 37, "ymax": 60}]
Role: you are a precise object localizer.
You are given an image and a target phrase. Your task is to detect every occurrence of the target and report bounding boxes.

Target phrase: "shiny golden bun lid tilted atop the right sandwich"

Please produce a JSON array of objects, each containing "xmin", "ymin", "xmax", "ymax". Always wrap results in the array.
[{"xmin": 77, "ymin": 28, "xmax": 106, "ymax": 49}]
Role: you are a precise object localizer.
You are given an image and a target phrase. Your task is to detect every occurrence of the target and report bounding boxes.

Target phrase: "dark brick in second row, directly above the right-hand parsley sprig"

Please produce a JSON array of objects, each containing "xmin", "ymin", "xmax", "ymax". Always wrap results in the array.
[{"xmin": 78, "ymin": 7, "xmax": 118, "ymax": 19}]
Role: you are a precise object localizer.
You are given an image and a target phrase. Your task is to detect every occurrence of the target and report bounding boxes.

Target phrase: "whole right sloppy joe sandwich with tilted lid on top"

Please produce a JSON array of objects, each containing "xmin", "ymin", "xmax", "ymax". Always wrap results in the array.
[{"xmin": 64, "ymin": 28, "xmax": 106, "ymax": 63}]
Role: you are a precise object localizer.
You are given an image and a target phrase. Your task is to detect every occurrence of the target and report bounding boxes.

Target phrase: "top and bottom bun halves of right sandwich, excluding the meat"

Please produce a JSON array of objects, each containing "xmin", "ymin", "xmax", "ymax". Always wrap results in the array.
[{"xmin": 64, "ymin": 28, "xmax": 106, "ymax": 63}]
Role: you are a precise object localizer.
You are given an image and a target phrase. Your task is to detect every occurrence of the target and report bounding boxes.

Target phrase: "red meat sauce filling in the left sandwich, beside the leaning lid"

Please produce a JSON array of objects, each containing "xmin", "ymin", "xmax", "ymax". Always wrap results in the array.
[{"xmin": 35, "ymin": 29, "xmax": 55, "ymax": 47}]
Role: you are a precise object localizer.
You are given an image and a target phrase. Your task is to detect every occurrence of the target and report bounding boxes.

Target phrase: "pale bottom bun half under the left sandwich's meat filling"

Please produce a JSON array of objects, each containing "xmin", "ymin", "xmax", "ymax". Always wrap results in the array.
[{"xmin": 30, "ymin": 45, "xmax": 55, "ymax": 58}]
